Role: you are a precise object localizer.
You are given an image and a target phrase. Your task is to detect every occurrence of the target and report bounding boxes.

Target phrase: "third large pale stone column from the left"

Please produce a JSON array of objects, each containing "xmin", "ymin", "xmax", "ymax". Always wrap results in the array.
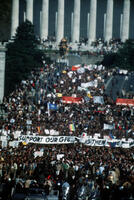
[{"xmin": 40, "ymin": 0, "xmax": 49, "ymax": 40}]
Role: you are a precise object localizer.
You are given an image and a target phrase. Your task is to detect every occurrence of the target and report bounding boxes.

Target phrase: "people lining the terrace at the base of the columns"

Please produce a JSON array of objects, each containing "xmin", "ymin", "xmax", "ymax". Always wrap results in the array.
[{"xmin": 41, "ymin": 38, "xmax": 123, "ymax": 55}]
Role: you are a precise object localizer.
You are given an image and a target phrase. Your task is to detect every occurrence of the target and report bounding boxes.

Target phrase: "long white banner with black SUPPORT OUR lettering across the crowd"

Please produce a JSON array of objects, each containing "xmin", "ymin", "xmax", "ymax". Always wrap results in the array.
[{"xmin": 18, "ymin": 135, "xmax": 134, "ymax": 148}]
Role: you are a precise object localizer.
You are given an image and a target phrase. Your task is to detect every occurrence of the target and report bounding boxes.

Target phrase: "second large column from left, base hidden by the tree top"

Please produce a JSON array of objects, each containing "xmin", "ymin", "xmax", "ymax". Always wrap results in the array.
[{"xmin": 26, "ymin": 0, "xmax": 33, "ymax": 23}]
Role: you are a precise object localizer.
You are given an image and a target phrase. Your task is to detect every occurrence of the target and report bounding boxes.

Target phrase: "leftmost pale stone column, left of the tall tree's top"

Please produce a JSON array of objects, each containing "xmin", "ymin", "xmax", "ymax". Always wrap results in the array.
[{"xmin": 11, "ymin": 0, "xmax": 19, "ymax": 38}]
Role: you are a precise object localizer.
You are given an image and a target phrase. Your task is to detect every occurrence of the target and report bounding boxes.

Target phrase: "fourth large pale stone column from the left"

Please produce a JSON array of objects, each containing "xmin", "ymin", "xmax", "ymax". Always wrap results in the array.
[{"xmin": 56, "ymin": 0, "xmax": 64, "ymax": 43}]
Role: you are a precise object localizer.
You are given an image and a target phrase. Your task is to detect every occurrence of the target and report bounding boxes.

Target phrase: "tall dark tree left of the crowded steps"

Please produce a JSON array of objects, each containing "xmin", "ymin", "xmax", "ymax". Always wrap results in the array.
[{"xmin": 5, "ymin": 20, "xmax": 44, "ymax": 94}]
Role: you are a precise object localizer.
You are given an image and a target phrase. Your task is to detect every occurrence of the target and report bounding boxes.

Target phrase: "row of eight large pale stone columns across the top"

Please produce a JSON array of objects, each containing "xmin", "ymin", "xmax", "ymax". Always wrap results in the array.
[{"xmin": 11, "ymin": 0, "xmax": 130, "ymax": 45}]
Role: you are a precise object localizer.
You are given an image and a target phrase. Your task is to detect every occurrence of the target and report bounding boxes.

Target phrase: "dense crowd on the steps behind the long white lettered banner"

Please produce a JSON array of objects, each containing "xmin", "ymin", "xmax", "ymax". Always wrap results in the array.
[{"xmin": 0, "ymin": 61, "xmax": 134, "ymax": 139}]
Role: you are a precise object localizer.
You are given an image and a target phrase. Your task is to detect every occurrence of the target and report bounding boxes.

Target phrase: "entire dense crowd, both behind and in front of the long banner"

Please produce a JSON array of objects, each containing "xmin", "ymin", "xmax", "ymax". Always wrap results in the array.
[{"xmin": 0, "ymin": 57, "xmax": 134, "ymax": 200}]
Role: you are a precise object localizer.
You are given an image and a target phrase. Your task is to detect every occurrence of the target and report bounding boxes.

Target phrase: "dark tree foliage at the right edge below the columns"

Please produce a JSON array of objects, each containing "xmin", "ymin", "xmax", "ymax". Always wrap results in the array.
[{"xmin": 102, "ymin": 40, "xmax": 134, "ymax": 71}]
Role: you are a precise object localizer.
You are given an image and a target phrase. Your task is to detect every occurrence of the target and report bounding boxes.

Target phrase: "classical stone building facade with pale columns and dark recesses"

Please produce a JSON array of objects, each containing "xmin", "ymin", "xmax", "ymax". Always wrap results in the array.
[{"xmin": 11, "ymin": 0, "xmax": 134, "ymax": 44}]
